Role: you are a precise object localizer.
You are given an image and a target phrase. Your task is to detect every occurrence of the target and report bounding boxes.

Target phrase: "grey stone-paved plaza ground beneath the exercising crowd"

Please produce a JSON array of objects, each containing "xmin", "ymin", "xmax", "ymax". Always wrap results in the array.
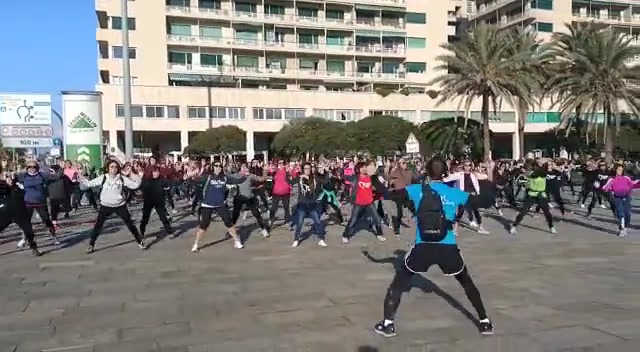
[{"xmin": 0, "ymin": 198, "xmax": 640, "ymax": 352}]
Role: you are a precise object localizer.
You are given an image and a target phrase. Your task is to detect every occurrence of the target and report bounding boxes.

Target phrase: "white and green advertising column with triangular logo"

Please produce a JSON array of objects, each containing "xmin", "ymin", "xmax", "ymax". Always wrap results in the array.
[{"xmin": 62, "ymin": 91, "xmax": 103, "ymax": 169}]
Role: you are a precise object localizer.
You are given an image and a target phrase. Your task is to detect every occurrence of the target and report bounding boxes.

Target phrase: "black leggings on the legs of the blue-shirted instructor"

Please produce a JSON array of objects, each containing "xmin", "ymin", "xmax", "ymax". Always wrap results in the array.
[{"xmin": 384, "ymin": 264, "xmax": 487, "ymax": 320}]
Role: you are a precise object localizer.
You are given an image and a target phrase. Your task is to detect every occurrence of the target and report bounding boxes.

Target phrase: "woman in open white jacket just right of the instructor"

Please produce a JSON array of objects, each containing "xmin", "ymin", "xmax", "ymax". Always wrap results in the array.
[{"xmin": 444, "ymin": 160, "xmax": 489, "ymax": 234}]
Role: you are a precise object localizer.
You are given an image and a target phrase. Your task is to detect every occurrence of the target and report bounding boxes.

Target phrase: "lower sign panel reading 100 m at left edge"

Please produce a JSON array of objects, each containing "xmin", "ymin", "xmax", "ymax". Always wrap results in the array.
[{"xmin": 0, "ymin": 125, "xmax": 53, "ymax": 148}]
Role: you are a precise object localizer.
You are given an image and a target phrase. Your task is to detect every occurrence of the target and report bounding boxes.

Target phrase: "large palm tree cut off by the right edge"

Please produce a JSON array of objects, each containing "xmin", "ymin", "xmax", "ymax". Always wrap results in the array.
[{"xmin": 549, "ymin": 23, "xmax": 640, "ymax": 160}]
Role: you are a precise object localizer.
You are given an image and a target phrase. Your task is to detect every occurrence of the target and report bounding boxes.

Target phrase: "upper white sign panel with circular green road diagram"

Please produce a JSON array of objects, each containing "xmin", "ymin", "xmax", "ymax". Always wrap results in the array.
[{"xmin": 0, "ymin": 94, "xmax": 51, "ymax": 125}]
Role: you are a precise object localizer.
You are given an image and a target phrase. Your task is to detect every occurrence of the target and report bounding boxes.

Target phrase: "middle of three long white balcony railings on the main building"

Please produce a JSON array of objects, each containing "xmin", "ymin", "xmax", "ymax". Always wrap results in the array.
[{"xmin": 167, "ymin": 34, "xmax": 406, "ymax": 56}]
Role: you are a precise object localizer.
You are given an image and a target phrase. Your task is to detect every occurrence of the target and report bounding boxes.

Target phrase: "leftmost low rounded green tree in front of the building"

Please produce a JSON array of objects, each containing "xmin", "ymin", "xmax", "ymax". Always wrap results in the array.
[{"xmin": 185, "ymin": 125, "xmax": 247, "ymax": 155}]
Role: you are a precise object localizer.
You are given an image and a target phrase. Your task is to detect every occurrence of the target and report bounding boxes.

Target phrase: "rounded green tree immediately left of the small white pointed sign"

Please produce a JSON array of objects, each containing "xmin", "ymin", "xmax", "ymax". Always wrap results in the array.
[{"xmin": 349, "ymin": 115, "xmax": 417, "ymax": 155}]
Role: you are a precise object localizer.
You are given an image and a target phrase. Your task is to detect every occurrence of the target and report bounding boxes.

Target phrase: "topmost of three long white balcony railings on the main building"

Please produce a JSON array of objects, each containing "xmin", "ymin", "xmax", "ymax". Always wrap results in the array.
[{"xmin": 166, "ymin": 6, "xmax": 406, "ymax": 29}]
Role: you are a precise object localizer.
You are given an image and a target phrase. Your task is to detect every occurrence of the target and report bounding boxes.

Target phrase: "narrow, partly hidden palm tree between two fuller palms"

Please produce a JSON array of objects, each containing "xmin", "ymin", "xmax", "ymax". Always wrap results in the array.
[{"xmin": 508, "ymin": 27, "xmax": 553, "ymax": 157}]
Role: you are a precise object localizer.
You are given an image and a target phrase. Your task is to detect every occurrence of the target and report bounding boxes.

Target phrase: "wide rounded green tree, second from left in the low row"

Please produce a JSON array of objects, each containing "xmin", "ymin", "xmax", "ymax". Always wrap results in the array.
[{"xmin": 271, "ymin": 117, "xmax": 352, "ymax": 156}]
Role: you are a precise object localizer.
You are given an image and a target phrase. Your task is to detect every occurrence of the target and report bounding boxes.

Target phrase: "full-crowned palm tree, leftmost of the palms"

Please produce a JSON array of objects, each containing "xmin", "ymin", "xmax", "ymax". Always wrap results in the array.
[{"xmin": 430, "ymin": 24, "xmax": 535, "ymax": 160}]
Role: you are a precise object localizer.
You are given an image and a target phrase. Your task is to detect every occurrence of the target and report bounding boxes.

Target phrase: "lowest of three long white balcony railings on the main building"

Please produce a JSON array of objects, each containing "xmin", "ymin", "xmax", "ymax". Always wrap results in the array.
[{"xmin": 167, "ymin": 63, "xmax": 407, "ymax": 81}]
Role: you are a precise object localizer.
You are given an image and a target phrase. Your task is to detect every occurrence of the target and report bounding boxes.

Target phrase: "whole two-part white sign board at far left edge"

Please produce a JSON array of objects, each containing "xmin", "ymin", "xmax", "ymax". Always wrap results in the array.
[{"xmin": 0, "ymin": 94, "xmax": 53, "ymax": 149}]
